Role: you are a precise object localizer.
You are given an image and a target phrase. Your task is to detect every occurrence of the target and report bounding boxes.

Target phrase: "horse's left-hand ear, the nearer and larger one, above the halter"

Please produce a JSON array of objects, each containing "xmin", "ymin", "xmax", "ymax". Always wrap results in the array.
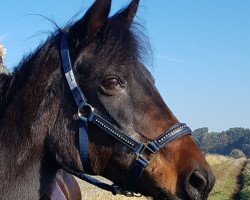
[{"xmin": 70, "ymin": 0, "xmax": 111, "ymax": 39}]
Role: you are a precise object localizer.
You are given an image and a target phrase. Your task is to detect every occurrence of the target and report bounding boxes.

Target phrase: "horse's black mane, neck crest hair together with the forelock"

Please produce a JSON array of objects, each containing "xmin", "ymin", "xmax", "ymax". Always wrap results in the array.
[{"xmin": 0, "ymin": 10, "xmax": 152, "ymax": 113}]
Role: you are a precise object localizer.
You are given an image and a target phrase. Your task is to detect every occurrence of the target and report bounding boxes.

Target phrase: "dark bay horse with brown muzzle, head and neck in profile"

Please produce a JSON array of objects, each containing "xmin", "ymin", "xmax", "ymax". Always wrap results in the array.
[{"xmin": 0, "ymin": 0, "xmax": 214, "ymax": 200}]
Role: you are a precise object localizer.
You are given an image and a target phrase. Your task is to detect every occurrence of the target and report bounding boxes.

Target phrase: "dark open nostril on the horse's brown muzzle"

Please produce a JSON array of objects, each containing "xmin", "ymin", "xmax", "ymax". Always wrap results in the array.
[{"xmin": 186, "ymin": 170, "xmax": 207, "ymax": 199}]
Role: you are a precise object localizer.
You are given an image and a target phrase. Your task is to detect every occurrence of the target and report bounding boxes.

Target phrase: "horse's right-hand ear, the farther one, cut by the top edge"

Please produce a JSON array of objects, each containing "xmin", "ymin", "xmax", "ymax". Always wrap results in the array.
[{"xmin": 114, "ymin": 0, "xmax": 139, "ymax": 27}]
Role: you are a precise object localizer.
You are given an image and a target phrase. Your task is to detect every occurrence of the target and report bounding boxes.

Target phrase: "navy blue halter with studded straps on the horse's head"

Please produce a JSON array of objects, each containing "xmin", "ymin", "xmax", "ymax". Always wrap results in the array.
[{"xmin": 61, "ymin": 33, "xmax": 191, "ymax": 196}]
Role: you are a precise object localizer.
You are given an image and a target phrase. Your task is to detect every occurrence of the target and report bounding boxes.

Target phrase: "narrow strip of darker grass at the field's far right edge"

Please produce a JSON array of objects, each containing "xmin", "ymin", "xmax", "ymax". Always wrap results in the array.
[{"xmin": 240, "ymin": 160, "xmax": 250, "ymax": 200}]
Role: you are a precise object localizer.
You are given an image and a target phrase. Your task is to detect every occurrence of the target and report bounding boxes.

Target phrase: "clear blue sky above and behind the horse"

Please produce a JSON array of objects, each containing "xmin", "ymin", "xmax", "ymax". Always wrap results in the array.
[{"xmin": 0, "ymin": 0, "xmax": 250, "ymax": 131}]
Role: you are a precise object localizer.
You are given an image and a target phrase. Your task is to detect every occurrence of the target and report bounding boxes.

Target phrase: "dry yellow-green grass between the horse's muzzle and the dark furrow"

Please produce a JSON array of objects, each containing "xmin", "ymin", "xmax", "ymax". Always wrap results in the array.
[{"xmin": 207, "ymin": 155, "xmax": 249, "ymax": 200}]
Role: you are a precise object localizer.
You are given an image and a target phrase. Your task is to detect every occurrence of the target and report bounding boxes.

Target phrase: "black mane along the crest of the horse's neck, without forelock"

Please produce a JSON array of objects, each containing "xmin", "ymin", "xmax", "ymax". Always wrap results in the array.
[{"xmin": 0, "ymin": 31, "xmax": 61, "ymax": 115}]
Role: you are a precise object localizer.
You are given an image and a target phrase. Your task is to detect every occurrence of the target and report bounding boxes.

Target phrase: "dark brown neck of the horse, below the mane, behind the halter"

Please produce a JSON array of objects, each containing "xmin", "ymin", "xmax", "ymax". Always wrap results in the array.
[{"xmin": 0, "ymin": 45, "xmax": 60, "ymax": 200}]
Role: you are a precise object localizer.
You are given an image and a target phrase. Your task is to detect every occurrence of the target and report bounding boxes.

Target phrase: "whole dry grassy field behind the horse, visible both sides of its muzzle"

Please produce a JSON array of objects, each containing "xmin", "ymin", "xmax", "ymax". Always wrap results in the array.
[{"xmin": 76, "ymin": 155, "xmax": 250, "ymax": 200}]
